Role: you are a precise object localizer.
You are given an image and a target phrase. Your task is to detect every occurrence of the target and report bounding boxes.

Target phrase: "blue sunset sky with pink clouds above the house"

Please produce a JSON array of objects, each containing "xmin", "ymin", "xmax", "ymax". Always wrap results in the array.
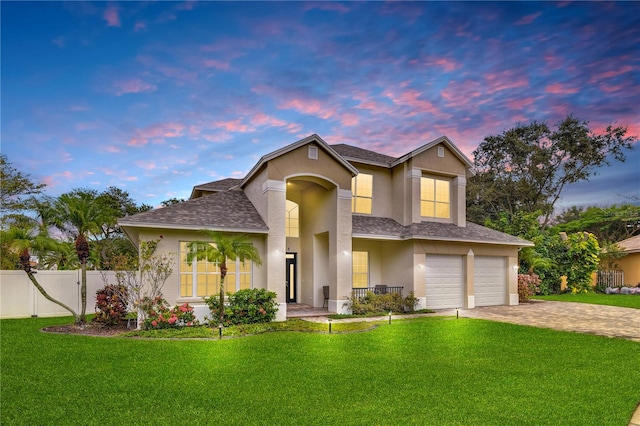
[{"xmin": 0, "ymin": 1, "xmax": 640, "ymax": 211}]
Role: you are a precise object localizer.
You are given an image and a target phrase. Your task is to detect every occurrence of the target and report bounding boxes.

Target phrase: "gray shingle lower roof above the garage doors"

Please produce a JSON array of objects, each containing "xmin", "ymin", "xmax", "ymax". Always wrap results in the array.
[{"xmin": 352, "ymin": 215, "xmax": 533, "ymax": 246}]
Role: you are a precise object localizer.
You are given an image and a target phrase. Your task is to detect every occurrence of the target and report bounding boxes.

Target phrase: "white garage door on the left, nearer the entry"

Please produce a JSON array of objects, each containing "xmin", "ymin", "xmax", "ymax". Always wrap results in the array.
[{"xmin": 426, "ymin": 254, "xmax": 464, "ymax": 309}]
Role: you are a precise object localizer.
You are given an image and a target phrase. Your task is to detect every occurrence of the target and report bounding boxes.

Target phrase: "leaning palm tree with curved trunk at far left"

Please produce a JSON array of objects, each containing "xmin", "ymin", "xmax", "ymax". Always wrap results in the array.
[{"xmin": 0, "ymin": 227, "xmax": 80, "ymax": 323}]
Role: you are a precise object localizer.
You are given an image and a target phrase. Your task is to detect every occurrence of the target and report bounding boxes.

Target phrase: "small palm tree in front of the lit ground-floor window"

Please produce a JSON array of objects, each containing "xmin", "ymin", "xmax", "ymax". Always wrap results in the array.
[{"xmin": 187, "ymin": 230, "xmax": 262, "ymax": 324}]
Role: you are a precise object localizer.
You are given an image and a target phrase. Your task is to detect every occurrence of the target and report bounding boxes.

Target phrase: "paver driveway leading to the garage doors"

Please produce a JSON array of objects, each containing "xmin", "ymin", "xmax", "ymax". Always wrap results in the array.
[{"xmin": 453, "ymin": 296, "xmax": 640, "ymax": 342}]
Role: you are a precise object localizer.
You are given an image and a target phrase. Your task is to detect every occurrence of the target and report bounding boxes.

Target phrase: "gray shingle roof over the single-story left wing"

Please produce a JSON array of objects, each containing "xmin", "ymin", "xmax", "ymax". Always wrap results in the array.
[{"xmin": 119, "ymin": 190, "xmax": 268, "ymax": 232}]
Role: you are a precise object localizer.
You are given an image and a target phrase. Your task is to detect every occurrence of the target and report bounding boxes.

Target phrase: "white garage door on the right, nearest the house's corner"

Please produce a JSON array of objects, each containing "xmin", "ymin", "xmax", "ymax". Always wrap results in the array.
[{"xmin": 473, "ymin": 256, "xmax": 507, "ymax": 306}]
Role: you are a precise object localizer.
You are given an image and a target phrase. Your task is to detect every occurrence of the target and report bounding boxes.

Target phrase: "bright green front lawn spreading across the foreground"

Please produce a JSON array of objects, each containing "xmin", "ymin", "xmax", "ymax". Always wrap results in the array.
[{"xmin": 0, "ymin": 317, "xmax": 640, "ymax": 426}]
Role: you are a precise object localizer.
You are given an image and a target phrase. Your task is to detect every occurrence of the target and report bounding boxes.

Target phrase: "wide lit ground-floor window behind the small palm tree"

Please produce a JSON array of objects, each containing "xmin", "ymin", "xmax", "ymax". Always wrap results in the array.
[{"xmin": 180, "ymin": 242, "xmax": 252, "ymax": 297}]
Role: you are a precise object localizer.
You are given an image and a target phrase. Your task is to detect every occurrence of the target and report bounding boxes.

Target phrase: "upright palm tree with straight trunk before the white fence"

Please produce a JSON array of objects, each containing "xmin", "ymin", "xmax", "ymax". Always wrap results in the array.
[{"xmin": 54, "ymin": 189, "xmax": 105, "ymax": 323}]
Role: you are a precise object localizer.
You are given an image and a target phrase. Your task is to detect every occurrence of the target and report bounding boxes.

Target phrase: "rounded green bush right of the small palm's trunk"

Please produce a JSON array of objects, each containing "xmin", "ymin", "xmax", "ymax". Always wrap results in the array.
[{"xmin": 204, "ymin": 288, "xmax": 278, "ymax": 326}]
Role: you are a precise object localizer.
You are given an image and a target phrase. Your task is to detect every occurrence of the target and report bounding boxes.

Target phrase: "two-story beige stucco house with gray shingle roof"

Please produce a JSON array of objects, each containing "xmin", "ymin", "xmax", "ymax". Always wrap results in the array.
[{"xmin": 120, "ymin": 135, "xmax": 532, "ymax": 320}]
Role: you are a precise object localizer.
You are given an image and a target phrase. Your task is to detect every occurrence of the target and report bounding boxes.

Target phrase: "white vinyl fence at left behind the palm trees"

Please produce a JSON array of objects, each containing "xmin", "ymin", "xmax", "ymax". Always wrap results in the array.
[{"xmin": 0, "ymin": 270, "xmax": 121, "ymax": 318}]
